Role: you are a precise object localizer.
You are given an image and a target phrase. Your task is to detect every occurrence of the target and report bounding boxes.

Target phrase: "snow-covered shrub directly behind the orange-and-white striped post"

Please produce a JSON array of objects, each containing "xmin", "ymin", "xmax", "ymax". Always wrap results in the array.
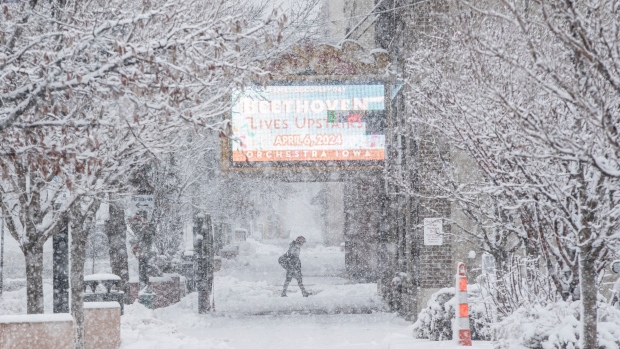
[{"xmin": 413, "ymin": 285, "xmax": 491, "ymax": 341}]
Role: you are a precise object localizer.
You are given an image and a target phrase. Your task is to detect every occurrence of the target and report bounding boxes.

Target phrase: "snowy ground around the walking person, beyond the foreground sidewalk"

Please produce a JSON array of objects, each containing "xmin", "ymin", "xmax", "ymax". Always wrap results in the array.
[{"xmin": 214, "ymin": 239, "xmax": 385, "ymax": 315}]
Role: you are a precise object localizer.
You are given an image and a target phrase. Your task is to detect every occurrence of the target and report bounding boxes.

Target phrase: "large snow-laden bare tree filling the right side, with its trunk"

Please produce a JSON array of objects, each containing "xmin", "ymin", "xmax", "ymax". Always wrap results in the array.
[{"xmin": 408, "ymin": 0, "xmax": 619, "ymax": 348}]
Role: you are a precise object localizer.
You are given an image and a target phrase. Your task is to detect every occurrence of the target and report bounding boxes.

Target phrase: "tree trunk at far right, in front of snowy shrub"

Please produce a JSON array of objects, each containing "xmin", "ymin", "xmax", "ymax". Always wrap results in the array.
[{"xmin": 579, "ymin": 251, "xmax": 598, "ymax": 349}]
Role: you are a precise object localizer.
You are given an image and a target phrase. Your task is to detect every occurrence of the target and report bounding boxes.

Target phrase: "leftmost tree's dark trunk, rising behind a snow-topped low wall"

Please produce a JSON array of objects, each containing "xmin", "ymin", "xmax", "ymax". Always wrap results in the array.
[{"xmin": 24, "ymin": 244, "xmax": 45, "ymax": 314}]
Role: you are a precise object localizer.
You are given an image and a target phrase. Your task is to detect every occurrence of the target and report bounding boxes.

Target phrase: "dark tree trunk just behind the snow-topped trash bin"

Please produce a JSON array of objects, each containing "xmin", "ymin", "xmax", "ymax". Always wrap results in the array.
[{"xmin": 105, "ymin": 202, "xmax": 130, "ymax": 304}]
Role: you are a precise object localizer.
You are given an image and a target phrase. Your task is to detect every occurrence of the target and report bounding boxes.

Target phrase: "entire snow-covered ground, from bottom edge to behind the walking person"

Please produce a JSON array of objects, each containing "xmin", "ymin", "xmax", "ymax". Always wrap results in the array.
[{"xmin": 0, "ymin": 240, "xmax": 491, "ymax": 349}]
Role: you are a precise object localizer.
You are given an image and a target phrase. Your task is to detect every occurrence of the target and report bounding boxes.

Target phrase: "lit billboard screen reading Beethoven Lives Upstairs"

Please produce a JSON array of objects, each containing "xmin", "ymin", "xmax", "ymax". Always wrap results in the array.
[{"xmin": 230, "ymin": 83, "xmax": 386, "ymax": 164}]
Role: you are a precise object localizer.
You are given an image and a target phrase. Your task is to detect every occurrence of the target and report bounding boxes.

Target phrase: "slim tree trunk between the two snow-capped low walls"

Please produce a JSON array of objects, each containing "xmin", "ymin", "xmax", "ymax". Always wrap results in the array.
[{"xmin": 71, "ymin": 218, "xmax": 86, "ymax": 349}]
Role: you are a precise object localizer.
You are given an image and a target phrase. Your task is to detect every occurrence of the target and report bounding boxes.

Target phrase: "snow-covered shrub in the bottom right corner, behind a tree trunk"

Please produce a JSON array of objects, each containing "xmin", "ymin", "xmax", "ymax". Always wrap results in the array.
[{"xmin": 492, "ymin": 301, "xmax": 620, "ymax": 349}]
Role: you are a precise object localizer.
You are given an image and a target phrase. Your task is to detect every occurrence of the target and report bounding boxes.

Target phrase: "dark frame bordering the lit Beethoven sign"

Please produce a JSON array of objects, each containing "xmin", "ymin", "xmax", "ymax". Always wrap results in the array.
[{"xmin": 221, "ymin": 75, "xmax": 392, "ymax": 172}]
